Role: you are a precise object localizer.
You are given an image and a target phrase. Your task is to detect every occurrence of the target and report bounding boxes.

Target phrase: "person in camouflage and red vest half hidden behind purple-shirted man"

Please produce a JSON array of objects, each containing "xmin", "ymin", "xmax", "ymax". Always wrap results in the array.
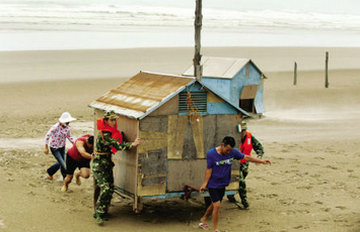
[{"xmin": 228, "ymin": 122, "xmax": 264, "ymax": 209}]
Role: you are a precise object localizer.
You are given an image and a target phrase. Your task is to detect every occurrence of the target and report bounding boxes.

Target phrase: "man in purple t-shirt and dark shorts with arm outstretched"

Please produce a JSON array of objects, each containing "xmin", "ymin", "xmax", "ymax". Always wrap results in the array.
[{"xmin": 199, "ymin": 136, "xmax": 271, "ymax": 231}]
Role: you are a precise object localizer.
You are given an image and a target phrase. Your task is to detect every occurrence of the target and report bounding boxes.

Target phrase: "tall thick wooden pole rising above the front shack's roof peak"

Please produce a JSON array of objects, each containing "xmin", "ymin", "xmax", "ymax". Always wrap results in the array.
[{"xmin": 193, "ymin": 0, "xmax": 202, "ymax": 81}]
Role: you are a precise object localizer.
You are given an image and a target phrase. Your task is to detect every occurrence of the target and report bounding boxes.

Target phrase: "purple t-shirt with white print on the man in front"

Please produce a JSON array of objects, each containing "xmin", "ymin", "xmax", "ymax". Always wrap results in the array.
[{"xmin": 206, "ymin": 148, "xmax": 245, "ymax": 188}]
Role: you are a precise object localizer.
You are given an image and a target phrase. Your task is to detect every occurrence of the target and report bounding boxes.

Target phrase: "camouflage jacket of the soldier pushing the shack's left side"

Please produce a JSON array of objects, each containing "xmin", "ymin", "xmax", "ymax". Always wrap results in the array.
[{"xmin": 95, "ymin": 131, "xmax": 132, "ymax": 154}]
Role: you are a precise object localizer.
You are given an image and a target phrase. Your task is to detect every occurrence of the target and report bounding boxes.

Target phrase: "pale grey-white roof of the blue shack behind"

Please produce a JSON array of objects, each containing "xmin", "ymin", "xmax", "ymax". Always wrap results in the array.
[{"xmin": 183, "ymin": 56, "xmax": 250, "ymax": 78}]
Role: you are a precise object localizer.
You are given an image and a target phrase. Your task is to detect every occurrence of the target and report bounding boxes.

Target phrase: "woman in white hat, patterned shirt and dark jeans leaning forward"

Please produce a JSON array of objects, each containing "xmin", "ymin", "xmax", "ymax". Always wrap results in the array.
[{"xmin": 44, "ymin": 112, "xmax": 76, "ymax": 179}]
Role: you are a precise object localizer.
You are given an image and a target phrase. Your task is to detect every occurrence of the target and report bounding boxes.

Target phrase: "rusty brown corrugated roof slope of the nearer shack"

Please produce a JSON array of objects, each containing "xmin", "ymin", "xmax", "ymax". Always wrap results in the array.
[{"xmin": 90, "ymin": 72, "xmax": 195, "ymax": 119}]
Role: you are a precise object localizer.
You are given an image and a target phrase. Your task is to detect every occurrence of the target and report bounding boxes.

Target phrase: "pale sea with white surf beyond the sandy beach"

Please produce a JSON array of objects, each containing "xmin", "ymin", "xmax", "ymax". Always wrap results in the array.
[{"xmin": 0, "ymin": 0, "xmax": 360, "ymax": 51}]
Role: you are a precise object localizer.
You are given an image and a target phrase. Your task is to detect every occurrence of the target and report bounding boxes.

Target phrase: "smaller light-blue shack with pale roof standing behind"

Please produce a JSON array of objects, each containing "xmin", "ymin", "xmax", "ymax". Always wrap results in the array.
[{"xmin": 183, "ymin": 56, "xmax": 266, "ymax": 115}]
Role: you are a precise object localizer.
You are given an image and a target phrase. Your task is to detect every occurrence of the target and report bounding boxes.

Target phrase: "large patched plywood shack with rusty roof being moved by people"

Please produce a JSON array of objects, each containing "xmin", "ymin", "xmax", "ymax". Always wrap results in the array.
[{"xmin": 90, "ymin": 72, "xmax": 247, "ymax": 211}]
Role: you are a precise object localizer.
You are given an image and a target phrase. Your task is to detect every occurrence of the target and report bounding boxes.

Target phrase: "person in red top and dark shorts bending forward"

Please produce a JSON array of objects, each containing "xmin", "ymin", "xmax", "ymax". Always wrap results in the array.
[{"xmin": 61, "ymin": 135, "xmax": 94, "ymax": 192}]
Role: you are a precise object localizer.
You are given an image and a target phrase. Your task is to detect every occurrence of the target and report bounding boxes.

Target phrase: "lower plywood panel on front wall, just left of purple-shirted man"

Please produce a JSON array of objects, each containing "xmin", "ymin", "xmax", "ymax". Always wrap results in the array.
[{"xmin": 167, "ymin": 159, "xmax": 206, "ymax": 192}]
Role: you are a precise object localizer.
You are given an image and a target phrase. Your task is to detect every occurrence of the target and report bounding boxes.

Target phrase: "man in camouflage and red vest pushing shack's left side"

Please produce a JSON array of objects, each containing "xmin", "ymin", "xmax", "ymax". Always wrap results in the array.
[{"xmin": 92, "ymin": 111, "xmax": 140, "ymax": 225}]
